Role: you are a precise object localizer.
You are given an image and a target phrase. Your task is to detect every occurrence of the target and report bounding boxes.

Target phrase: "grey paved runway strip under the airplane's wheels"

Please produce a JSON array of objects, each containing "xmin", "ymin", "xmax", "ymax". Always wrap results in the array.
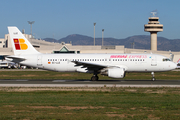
[{"xmin": 0, "ymin": 80, "xmax": 180, "ymax": 87}]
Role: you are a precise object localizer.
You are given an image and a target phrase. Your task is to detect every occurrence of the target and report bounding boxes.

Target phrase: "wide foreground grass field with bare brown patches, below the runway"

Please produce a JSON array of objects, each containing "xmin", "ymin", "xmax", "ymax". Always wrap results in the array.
[{"xmin": 0, "ymin": 87, "xmax": 180, "ymax": 120}]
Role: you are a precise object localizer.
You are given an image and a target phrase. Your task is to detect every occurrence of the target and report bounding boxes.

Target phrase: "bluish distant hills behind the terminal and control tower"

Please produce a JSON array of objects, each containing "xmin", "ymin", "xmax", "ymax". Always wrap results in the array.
[{"xmin": 44, "ymin": 34, "xmax": 180, "ymax": 51}]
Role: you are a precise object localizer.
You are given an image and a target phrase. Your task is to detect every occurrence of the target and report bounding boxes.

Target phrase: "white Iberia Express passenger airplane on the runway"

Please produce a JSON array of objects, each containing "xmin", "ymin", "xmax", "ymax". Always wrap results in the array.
[{"xmin": 7, "ymin": 26, "xmax": 177, "ymax": 81}]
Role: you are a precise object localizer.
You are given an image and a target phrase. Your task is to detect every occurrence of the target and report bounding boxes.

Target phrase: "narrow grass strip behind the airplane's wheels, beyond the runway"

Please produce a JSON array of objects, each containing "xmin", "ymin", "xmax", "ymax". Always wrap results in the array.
[{"xmin": 0, "ymin": 71, "xmax": 180, "ymax": 80}]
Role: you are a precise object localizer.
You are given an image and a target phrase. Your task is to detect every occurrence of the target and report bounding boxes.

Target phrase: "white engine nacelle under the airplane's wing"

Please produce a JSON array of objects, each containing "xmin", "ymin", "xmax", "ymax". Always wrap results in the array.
[{"xmin": 108, "ymin": 68, "xmax": 125, "ymax": 78}]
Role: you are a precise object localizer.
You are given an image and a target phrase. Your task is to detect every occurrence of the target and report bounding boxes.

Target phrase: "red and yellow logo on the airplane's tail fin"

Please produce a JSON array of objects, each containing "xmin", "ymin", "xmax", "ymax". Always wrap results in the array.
[{"xmin": 14, "ymin": 38, "xmax": 28, "ymax": 50}]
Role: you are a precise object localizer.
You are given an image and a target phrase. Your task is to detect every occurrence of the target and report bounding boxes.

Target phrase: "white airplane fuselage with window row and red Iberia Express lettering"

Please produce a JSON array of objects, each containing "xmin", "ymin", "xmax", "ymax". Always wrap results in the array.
[{"xmin": 21, "ymin": 54, "xmax": 176, "ymax": 72}]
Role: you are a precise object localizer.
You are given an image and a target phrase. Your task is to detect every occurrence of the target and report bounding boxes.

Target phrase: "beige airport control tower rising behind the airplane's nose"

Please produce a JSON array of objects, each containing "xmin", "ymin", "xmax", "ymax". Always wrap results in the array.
[{"xmin": 144, "ymin": 12, "xmax": 163, "ymax": 51}]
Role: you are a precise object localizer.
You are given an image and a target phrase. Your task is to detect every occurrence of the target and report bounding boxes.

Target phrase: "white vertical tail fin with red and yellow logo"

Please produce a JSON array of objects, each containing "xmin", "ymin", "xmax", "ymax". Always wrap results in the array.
[{"xmin": 8, "ymin": 27, "xmax": 39, "ymax": 55}]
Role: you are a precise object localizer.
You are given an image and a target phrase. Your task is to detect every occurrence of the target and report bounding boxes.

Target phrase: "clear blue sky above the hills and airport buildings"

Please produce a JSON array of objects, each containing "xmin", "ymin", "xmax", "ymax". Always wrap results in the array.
[{"xmin": 0, "ymin": 0, "xmax": 180, "ymax": 39}]
